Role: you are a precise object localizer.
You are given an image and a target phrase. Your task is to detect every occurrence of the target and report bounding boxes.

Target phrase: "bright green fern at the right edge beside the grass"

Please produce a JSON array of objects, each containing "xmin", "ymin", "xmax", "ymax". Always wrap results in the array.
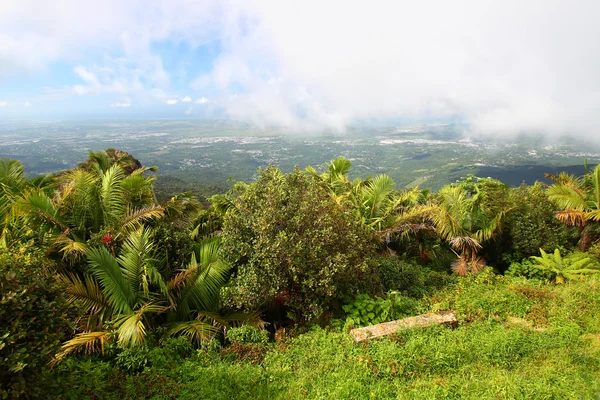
[{"xmin": 531, "ymin": 249, "xmax": 600, "ymax": 284}]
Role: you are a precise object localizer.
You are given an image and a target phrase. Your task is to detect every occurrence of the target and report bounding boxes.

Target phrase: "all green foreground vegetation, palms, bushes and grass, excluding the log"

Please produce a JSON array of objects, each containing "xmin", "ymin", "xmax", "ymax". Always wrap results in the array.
[{"xmin": 0, "ymin": 150, "xmax": 600, "ymax": 399}]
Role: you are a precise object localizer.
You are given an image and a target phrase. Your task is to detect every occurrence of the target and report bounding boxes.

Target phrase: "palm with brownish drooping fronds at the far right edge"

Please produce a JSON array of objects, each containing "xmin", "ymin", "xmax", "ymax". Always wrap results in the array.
[{"xmin": 548, "ymin": 165, "xmax": 600, "ymax": 250}]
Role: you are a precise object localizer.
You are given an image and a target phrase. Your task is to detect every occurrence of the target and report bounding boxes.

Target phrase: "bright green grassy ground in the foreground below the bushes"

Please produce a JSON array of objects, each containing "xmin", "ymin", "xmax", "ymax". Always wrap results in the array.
[{"xmin": 44, "ymin": 273, "xmax": 600, "ymax": 399}]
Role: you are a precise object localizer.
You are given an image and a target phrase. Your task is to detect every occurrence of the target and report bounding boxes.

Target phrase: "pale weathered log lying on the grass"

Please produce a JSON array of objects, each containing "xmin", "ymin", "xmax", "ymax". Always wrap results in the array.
[{"xmin": 350, "ymin": 311, "xmax": 458, "ymax": 343}]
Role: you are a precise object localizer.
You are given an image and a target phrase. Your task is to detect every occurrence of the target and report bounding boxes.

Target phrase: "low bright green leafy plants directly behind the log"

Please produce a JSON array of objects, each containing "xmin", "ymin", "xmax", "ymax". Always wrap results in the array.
[{"xmin": 342, "ymin": 291, "xmax": 420, "ymax": 327}]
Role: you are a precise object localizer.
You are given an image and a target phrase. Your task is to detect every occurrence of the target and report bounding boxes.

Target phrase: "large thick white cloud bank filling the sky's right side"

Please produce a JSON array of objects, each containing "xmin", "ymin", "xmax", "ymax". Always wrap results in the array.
[{"xmin": 202, "ymin": 0, "xmax": 600, "ymax": 136}]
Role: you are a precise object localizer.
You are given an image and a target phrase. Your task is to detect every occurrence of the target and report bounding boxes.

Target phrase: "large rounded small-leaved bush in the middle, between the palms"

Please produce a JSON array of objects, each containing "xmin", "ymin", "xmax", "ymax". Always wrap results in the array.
[{"xmin": 222, "ymin": 167, "xmax": 373, "ymax": 321}]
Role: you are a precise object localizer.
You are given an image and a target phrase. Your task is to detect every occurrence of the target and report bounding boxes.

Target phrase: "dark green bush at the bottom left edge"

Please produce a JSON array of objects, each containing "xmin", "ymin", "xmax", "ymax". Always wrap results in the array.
[{"xmin": 0, "ymin": 248, "xmax": 75, "ymax": 398}]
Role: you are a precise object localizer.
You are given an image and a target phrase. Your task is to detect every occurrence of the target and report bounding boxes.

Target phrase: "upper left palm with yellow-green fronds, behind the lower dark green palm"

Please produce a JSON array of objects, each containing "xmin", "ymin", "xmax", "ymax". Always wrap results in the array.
[{"xmin": 18, "ymin": 158, "xmax": 164, "ymax": 259}]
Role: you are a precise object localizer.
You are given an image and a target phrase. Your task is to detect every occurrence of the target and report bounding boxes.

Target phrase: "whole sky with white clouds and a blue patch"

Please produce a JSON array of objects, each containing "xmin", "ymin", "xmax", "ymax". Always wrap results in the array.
[{"xmin": 0, "ymin": 0, "xmax": 600, "ymax": 138}]
